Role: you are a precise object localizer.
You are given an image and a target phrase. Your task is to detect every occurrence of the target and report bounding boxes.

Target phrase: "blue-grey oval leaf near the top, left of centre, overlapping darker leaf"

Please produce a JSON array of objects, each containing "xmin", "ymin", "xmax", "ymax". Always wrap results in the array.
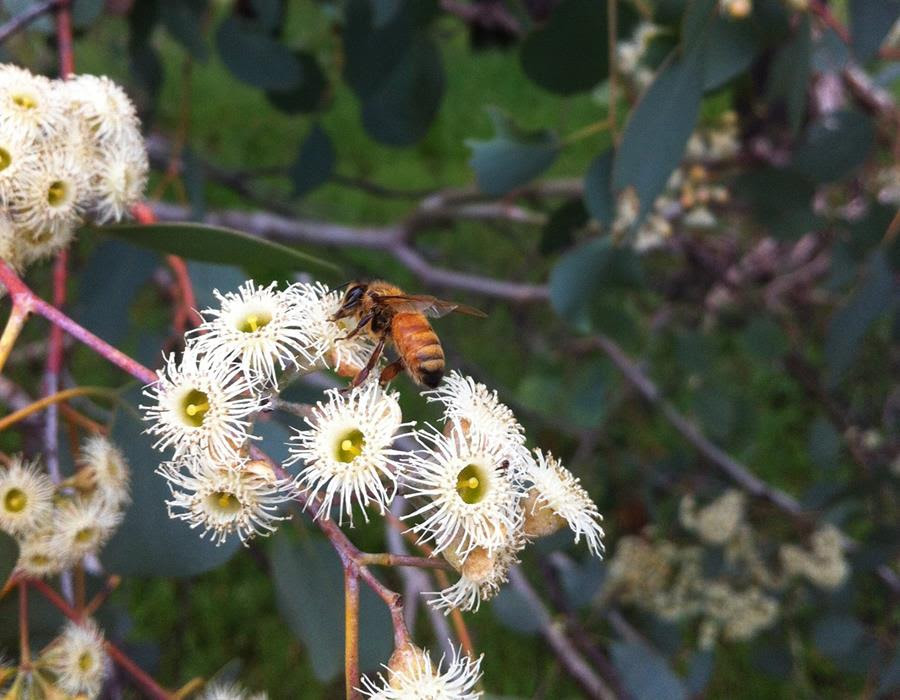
[{"xmin": 216, "ymin": 17, "xmax": 303, "ymax": 92}]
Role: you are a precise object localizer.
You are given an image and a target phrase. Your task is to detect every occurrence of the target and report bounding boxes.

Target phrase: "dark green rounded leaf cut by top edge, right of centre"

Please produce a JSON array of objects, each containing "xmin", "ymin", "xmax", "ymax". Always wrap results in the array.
[{"xmin": 519, "ymin": 0, "xmax": 609, "ymax": 95}]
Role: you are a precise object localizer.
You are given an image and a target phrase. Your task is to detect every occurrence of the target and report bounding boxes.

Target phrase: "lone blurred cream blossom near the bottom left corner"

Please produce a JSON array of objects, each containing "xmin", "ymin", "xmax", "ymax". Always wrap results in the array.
[{"xmin": 37, "ymin": 620, "xmax": 109, "ymax": 698}]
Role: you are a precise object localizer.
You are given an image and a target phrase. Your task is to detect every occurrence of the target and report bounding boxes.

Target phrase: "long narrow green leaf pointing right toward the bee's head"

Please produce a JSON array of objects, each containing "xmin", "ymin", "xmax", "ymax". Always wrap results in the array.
[{"xmin": 99, "ymin": 223, "xmax": 338, "ymax": 272}]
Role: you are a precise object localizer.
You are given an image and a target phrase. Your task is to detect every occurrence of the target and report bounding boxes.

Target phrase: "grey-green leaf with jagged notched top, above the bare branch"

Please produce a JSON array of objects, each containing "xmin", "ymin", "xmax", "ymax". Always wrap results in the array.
[{"xmin": 466, "ymin": 107, "xmax": 561, "ymax": 197}]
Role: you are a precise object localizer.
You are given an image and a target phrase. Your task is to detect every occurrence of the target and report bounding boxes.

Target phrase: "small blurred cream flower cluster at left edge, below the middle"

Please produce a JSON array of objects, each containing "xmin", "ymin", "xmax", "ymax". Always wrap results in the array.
[{"xmin": 0, "ymin": 436, "xmax": 129, "ymax": 577}]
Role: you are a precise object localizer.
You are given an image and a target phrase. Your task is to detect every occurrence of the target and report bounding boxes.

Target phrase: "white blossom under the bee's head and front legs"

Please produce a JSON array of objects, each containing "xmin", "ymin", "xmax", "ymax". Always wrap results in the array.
[{"xmin": 286, "ymin": 282, "xmax": 375, "ymax": 376}]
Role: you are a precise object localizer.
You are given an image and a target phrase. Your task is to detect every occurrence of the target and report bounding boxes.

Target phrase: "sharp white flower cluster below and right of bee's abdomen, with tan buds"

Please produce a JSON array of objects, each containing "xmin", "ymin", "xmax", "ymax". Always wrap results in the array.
[{"xmin": 403, "ymin": 371, "xmax": 603, "ymax": 612}]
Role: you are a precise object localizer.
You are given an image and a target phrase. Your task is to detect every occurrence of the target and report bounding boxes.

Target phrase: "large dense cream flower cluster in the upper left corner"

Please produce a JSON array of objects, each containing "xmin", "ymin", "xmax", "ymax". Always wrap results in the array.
[{"xmin": 0, "ymin": 64, "xmax": 148, "ymax": 268}]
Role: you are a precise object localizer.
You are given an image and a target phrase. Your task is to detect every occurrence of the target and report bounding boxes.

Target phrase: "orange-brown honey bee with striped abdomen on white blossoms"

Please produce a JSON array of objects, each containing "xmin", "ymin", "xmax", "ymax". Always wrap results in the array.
[{"xmin": 331, "ymin": 280, "xmax": 486, "ymax": 389}]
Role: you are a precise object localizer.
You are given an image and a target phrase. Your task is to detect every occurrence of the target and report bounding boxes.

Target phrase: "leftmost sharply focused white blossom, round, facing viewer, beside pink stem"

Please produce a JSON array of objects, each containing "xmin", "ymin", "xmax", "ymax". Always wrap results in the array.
[{"xmin": 141, "ymin": 346, "xmax": 263, "ymax": 459}]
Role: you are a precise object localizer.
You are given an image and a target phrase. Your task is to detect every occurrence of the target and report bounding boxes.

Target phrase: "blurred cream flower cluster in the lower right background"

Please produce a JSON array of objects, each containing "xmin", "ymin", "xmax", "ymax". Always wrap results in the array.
[{"xmin": 604, "ymin": 489, "xmax": 848, "ymax": 648}]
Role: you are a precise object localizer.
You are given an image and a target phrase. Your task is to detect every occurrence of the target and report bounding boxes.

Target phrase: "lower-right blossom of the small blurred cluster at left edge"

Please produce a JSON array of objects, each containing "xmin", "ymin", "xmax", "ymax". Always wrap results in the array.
[{"xmin": 47, "ymin": 496, "xmax": 122, "ymax": 563}]
